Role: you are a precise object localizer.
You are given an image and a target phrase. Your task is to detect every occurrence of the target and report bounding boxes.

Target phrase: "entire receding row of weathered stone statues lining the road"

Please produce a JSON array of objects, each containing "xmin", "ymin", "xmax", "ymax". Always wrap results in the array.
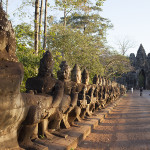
[{"xmin": 0, "ymin": 7, "xmax": 126, "ymax": 150}]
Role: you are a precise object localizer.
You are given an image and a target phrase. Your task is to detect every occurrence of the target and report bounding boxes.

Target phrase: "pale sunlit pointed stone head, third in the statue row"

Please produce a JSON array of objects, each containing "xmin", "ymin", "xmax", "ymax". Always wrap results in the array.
[{"xmin": 71, "ymin": 64, "xmax": 81, "ymax": 83}]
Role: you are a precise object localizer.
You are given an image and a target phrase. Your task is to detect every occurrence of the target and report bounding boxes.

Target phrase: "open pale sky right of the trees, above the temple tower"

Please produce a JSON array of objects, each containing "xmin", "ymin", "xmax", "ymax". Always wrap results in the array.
[{"xmin": 101, "ymin": 0, "xmax": 150, "ymax": 55}]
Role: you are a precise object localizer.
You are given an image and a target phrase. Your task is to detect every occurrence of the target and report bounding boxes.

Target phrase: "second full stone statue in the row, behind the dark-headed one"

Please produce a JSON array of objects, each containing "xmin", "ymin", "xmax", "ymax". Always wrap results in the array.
[{"xmin": 57, "ymin": 61, "xmax": 81, "ymax": 128}]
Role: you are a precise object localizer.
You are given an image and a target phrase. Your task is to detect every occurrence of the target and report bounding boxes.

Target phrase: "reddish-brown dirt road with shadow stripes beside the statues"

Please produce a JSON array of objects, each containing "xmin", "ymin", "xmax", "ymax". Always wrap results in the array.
[{"xmin": 76, "ymin": 91, "xmax": 150, "ymax": 150}]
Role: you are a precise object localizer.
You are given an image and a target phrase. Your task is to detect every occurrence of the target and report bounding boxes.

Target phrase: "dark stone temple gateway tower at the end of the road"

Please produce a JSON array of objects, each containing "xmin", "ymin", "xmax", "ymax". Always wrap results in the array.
[{"xmin": 119, "ymin": 44, "xmax": 150, "ymax": 89}]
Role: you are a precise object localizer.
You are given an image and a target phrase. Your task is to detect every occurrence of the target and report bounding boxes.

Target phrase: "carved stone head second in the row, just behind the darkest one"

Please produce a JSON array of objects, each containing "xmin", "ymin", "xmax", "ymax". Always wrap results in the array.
[{"xmin": 57, "ymin": 61, "xmax": 71, "ymax": 80}]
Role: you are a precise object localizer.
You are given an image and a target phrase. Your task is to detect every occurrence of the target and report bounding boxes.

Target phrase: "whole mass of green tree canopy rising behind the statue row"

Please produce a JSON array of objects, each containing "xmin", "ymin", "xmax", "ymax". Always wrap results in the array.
[{"xmin": 9, "ymin": 0, "xmax": 131, "ymax": 91}]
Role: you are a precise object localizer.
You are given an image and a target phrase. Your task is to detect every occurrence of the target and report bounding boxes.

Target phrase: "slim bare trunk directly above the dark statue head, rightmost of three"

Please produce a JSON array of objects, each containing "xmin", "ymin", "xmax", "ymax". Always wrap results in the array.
[{"xmin": 43, "ymin": 0, "xmax": 47, "ymax": 51}]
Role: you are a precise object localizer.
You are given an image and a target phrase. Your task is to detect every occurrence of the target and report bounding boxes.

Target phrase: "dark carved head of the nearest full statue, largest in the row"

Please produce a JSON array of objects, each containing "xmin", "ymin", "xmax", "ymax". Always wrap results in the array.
[{"xmin": 38, "ymin": 51, "xmax": 54, "ymax": 77}]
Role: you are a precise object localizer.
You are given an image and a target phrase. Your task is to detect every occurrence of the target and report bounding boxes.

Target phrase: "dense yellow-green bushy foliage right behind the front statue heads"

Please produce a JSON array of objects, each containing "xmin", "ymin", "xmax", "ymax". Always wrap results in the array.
[{"xmin": 47, "ymin": 24, "xmax": 103, "ymax": 82}]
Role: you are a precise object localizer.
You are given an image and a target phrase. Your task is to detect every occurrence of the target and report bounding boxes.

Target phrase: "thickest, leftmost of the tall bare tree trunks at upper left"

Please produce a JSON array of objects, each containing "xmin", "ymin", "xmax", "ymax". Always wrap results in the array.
[{"xmin": 34, "ymin": 0, "xmax": 39, "ymax": 55}]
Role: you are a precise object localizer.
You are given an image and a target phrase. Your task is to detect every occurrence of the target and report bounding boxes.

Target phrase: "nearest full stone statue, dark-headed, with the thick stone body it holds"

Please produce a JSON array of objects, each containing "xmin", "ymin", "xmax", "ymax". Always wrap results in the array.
[{"xmin": 19, "ymin": 51, "xmax": 64, "ymax": 149}]
